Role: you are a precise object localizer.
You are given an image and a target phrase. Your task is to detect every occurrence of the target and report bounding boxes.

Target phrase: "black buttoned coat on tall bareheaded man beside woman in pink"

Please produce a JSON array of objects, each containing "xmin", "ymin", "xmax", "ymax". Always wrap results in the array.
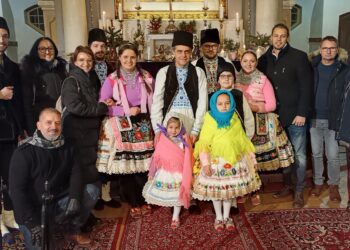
[{"xmin": 258, "ymin": 44, "xmax": 313, "ymax": 127}]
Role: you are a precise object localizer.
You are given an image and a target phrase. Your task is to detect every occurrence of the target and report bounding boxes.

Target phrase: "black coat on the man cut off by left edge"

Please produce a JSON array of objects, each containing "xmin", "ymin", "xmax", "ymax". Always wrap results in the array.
[{"xmin": 0, "ymin": 54, "xmax": 24, "ymax": 141}]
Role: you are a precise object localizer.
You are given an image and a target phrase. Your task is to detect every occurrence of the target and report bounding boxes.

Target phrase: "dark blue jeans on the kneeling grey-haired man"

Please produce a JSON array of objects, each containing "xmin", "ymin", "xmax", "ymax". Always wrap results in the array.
[{"xmin": 19, "ymin": 183, "xmax": 100, "ymax": 250}]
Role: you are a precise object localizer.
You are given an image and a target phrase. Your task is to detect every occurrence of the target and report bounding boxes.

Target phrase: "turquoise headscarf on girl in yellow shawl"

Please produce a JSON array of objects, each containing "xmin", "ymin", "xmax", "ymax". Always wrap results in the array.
[{"xmin": 209, "ymin": 90, "xmax": 236, "ymax": 128}]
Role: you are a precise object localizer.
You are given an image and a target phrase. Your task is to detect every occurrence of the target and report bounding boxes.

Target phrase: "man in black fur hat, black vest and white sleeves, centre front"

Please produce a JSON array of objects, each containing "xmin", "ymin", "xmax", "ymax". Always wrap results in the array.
[{"xmin": 151, "ymin": 31, "xmax": 208, "ymax": 213}]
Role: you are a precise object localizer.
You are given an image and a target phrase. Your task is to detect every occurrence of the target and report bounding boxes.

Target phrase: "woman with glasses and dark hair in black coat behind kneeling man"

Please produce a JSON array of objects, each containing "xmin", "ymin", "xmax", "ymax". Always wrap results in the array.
[{"xmin": 21, "ymin": 37, "xmax": 67, "ymax": 135}]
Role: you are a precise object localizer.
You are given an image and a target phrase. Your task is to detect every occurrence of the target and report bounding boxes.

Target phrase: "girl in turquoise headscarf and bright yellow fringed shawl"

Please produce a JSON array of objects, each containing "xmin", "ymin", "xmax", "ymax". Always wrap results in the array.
[{"xmin": 192, "ymin": 90, "xmax": 261, "ymax": 231}]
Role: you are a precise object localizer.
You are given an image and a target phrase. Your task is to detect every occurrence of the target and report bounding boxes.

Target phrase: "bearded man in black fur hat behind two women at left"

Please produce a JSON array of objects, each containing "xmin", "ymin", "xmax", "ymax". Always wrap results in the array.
[{"xmin": 88, "ymin": 28, "xmax": 114, "ymax": 85}]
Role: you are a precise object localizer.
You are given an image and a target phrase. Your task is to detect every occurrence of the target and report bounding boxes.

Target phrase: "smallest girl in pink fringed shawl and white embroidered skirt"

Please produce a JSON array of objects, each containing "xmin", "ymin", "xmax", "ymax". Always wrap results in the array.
[{"xmin": 143, "ymin": 113, "xmax": 194, "ymax": 229}]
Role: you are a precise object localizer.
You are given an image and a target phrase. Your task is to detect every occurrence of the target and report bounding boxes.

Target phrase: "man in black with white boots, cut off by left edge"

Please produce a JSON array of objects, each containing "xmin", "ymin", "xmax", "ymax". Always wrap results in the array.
[{"xmin": 0, "ymin": 17, "xmax": 24, "ymax": 239}]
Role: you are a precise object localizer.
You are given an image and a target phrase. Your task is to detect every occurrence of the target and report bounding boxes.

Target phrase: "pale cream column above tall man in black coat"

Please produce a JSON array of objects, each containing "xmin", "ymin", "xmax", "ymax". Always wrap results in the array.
[{"xmin": 255, "ymin": 0, "xmax": 279, "ymax": 35}]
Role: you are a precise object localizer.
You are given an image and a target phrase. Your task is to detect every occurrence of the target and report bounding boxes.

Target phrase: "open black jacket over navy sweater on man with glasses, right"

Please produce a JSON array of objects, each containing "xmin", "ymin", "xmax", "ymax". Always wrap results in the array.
[{"xmin": 312, "ymin": 55, "xmax": 350, "ymax": 131}]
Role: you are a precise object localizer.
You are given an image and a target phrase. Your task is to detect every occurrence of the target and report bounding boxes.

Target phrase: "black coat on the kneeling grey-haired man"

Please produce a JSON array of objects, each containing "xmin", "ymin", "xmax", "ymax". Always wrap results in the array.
[{"xmin": 9, "ymin": 138, "xmax": 83, "ymax": 228}]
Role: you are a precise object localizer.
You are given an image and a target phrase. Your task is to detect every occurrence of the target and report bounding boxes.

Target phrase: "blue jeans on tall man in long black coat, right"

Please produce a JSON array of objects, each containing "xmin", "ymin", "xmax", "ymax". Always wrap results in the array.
[{"xmin": 283, "ymin": 125, "xmax": 307, "ymax": 192}]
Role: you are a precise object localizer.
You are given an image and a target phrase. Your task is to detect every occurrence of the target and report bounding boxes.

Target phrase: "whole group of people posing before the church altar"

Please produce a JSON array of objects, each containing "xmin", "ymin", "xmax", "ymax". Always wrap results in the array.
[{"xmin": 0, "ymin": 12, "xmax": 350, "ymax": 249}]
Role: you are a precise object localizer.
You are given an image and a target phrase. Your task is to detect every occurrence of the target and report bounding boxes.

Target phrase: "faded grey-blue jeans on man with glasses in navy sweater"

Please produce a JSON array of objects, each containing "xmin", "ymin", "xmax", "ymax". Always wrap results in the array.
[{"xmin": 310, "ymin": 119, "xmax": 340, "ymax": 185}]
